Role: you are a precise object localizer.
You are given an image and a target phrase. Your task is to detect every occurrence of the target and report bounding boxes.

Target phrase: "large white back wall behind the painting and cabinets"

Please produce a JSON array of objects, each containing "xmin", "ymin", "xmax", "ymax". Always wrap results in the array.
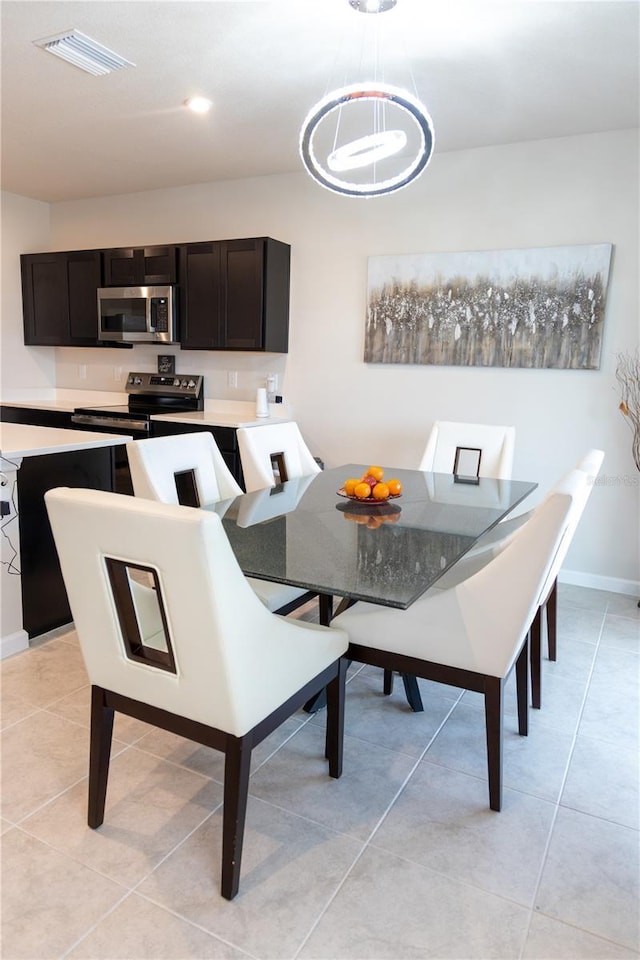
[{"xmin": 7, "ymin": 131, "xmax": 640, "ymax": 592}]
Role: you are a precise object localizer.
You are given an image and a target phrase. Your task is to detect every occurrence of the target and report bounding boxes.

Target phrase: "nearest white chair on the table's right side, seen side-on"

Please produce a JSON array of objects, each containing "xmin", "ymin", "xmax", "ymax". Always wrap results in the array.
[{"xmin": 333, "ymin": 494, "xmax": 572, "ymax": 810}]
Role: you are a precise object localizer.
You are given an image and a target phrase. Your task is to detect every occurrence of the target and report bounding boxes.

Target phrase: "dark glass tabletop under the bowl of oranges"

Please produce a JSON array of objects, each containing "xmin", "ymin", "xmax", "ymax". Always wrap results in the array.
[{"xmin": 218, "ymin": 464, "xmax": 537, "ymax": 609}]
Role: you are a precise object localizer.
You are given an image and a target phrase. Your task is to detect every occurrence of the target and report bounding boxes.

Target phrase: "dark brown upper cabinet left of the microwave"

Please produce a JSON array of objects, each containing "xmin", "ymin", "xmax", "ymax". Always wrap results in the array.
[{"xmin": 20, "ymin": 250, "xmax": 102, "ymax": 347}]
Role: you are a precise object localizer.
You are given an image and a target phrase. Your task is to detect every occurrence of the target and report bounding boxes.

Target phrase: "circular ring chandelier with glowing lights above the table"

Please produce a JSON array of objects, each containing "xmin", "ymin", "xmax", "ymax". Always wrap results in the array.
[{"xmin": 300, "ymin": 83, "xmax": 434, "ymax": 197}]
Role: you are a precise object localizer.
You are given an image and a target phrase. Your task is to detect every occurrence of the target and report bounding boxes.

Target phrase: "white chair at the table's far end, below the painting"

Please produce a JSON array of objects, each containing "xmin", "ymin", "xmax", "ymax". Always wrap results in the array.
[{"xmin": 418, "ymin": 420, "xmax": 516, "ymax": 480}]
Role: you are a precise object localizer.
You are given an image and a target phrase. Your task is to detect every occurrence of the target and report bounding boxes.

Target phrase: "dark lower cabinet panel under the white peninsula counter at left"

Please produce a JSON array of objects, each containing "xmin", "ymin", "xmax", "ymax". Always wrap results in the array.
[{"xmin": 18, "ymin": 447, "xmax": 114, "ymax": 637}]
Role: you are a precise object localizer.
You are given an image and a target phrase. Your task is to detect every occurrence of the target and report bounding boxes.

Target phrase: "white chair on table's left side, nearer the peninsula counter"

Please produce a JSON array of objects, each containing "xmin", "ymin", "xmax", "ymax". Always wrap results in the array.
[{"xmin": 127, "ymin": 430, "xmax": 315, "ymax": 614}]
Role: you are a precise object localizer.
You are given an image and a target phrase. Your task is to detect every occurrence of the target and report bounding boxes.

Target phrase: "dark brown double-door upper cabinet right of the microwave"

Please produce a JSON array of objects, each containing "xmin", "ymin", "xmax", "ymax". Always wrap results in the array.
[{"xmin": 180, "ymin": 237, "xmax": 291, "ymax": 353}]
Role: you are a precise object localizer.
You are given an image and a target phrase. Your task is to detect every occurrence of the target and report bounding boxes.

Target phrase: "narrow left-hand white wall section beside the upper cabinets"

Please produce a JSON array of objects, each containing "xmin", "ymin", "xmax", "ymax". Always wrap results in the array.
[{"xmin": 0, "ymin": 191, "xmax": 56, "ymax": 389}]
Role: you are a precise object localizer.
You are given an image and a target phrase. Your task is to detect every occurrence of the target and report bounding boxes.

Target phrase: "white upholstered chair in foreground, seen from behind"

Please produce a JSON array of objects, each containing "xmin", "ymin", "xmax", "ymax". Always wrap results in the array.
[{"xmin": 45, "ymin": 488, "xmax": 347, "ymax": 900}]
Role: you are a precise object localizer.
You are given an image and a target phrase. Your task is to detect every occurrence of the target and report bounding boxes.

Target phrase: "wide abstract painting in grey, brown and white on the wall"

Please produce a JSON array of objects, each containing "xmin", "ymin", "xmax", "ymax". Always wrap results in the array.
[{"xmin": 364, "ymin": 243, "xmax": 612, "ymax": 370}]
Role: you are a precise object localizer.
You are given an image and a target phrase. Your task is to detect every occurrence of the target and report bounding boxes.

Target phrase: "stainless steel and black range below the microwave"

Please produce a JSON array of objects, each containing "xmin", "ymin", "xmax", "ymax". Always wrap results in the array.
[{"xmin": 71, "ymin": 373, "xmax": 204, "ymax": 493}]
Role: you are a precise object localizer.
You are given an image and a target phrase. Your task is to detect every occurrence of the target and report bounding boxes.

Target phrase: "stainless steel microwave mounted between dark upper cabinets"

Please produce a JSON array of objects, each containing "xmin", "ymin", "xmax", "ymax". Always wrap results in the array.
[{"xmin": 98, "ymin": 286, "xmax": 178, "ymax": 343}]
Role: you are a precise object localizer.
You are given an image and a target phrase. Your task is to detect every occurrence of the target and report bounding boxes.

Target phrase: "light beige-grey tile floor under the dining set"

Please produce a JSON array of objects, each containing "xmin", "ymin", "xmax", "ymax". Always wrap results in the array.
[{"xmin": 0, "ymin": 585, "xmax": 640, "ymax": 960}]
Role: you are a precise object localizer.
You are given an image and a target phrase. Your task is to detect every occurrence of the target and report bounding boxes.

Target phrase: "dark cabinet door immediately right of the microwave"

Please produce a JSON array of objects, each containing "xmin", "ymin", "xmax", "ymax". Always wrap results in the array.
[{"xmin": 180, "ymin": 240, "xmax": 221, "ymax": 350}]
